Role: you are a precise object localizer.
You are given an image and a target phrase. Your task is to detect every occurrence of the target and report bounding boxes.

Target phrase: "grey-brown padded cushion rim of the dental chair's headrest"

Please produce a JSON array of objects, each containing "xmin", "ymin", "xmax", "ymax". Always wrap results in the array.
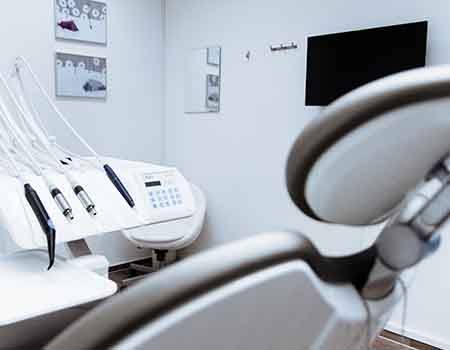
[{"xmin": 286, "ymin": 65, "xmax": 450, "ymax": 221}]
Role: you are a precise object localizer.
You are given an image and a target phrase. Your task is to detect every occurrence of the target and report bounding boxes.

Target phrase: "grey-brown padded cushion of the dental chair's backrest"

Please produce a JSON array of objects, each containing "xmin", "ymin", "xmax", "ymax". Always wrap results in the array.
[{"xmin": 46, "ymin": 233, "xmax": 317, "ymax": 350}]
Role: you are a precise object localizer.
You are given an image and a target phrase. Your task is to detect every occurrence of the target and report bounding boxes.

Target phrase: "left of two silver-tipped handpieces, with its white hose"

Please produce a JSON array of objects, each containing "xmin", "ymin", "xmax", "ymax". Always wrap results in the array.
[{"xmin": 0, "ymin": 75, "xmax": 73, "ymax": 220}]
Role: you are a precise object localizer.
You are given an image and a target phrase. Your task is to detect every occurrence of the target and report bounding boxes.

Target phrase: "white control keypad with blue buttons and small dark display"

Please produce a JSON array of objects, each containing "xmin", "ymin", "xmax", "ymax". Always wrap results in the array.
[{"xmin": 136, "ymin": 169, "xmax": 195, "ymax": 222}]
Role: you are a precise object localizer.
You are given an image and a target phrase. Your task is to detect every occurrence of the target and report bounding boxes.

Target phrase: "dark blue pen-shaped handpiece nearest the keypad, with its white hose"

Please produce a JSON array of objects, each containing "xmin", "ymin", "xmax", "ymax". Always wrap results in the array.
[{"xmin": 16, "ymin": 57, "xmax": 135, "ymax": 208}]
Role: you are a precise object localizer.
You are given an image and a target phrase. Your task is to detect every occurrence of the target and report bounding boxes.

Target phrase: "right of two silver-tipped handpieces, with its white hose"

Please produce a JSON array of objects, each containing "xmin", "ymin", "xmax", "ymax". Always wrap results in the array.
[{"xmin": 6, "ymin": 67, "xmax": 97, "ymax": 216}]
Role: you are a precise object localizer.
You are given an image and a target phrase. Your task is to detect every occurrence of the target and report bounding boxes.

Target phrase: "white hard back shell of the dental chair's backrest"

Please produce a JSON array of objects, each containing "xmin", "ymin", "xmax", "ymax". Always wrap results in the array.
[{"xmin": 113, "ymin": 260, "xmax": 366, "ymax": 350}]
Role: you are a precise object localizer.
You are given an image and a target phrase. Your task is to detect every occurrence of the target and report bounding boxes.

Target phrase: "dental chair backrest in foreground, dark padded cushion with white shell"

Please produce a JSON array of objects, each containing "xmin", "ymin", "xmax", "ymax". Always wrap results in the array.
[{"xmin": 47, "ymin": 232, "xmax": 376, "ymax": 350}]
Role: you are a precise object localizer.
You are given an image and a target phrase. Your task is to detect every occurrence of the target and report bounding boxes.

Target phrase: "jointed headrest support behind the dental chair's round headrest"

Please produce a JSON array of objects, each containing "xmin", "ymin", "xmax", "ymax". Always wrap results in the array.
[{"xmin": 362, "ymin": 157, "xmax": 450, "ymax": 300}]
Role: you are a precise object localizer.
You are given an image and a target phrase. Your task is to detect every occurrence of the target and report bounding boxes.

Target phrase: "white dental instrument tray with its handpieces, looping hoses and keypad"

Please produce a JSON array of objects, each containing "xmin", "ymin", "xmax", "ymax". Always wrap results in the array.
[{"xmin": 0, "ymin": 57, "xmax": 204, "ymax": 269}]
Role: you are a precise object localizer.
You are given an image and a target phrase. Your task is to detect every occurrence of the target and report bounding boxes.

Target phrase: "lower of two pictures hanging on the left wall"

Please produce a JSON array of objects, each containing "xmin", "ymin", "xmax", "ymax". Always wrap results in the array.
[{"xmin": 55, "ymin": 52, "xmax": 108, "ymax": 99}]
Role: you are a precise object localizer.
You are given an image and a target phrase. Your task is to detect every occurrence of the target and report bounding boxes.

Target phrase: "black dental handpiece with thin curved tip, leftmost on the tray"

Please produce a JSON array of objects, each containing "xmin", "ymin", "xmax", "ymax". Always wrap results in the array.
[{"xmin": 24, "ymin": 183, "xmax": 56, "ymax": 270}]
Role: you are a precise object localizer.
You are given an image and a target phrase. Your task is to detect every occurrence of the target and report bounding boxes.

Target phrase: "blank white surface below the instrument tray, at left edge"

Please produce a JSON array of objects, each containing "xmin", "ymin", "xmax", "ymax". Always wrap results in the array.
[{"xmin": 0, "ymin": 251, "xmax": 117, "ymax": 326}]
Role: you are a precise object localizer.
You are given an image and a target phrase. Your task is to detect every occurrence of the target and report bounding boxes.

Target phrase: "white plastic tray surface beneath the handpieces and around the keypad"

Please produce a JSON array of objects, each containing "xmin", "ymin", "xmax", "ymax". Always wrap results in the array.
[{"xmin": 0, "ymin": 159, "xmax": 195, "ymax": 249}]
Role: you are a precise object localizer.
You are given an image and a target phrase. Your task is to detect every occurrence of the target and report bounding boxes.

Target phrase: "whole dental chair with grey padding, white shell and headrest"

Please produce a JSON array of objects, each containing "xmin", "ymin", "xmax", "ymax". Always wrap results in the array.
[{"xmin": 47, "ymin": 66, "xmax": 450, "ymax": 350}]
